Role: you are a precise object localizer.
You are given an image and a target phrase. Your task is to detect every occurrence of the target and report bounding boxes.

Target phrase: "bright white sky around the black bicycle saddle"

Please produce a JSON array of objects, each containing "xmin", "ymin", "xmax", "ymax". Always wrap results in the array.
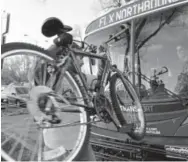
[{"xmin": 2, "ymin": 0, "xmax": 102, "ymax": 47}]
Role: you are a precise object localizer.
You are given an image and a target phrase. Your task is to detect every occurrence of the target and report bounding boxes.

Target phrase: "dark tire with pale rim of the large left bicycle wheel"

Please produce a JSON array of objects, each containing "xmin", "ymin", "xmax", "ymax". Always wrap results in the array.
[{"xmin": 1, "ymin": 42, "xmax": 90, "ymax": 161}]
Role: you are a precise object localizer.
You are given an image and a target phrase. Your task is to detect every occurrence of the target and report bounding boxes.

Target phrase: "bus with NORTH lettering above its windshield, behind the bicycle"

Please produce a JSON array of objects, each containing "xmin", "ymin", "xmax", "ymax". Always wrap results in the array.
[{"xmin": 85, "ymin": 0, "xmax": 188, "ymax": 159}]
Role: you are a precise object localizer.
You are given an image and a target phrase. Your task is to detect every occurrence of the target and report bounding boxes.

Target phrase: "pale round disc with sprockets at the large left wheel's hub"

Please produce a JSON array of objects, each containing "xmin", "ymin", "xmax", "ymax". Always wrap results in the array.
[{"xmin": 27, "ymin": 86, "xmax": 61, "ymax": 125}]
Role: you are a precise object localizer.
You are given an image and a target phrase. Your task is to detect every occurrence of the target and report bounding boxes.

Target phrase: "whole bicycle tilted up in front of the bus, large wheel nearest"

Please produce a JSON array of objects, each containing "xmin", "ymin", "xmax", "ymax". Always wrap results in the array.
[{"xmin": 1, "ymin": 17, "xmax": 145, "ymax": 161}]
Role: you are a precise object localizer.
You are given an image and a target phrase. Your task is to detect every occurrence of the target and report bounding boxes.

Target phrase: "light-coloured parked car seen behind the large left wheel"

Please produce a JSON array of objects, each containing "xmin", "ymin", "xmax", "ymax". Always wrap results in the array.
[{"xmin": 1, "ymin": 85, "xmax": 29, "ymax": 107}]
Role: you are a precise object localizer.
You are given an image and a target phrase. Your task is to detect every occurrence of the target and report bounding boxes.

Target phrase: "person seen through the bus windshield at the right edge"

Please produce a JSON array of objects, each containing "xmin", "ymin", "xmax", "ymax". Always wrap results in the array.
[{"xmin": 175, "ymin": 45, "xmax": 188, "ymax": 95}]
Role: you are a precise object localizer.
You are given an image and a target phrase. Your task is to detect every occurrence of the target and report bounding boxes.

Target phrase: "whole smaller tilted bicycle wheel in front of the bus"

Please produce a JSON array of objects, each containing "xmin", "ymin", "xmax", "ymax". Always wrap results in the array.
[{"xmin": 110, "ymin": 73, "xmax": 146, "ymax": 140}]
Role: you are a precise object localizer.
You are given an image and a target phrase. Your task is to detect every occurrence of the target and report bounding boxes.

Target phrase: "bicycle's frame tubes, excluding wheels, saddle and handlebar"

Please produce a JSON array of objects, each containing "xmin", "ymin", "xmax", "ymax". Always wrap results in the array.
[{"xmin": 47, "ymin": 44, "xmax": 113, "ymax": 111}]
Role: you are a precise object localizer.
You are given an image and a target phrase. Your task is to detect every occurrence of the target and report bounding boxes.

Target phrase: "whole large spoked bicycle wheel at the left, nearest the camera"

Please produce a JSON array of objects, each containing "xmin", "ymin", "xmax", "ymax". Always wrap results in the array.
[{"xmin": 1, "ymin": 43, "xmax": 89, "ymax": 161}]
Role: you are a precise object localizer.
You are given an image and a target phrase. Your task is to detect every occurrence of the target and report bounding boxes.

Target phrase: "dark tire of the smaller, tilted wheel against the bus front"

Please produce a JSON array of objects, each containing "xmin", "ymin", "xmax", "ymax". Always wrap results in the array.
[{"xmin": 110, "ymin": 73, "xmax": 146, "ymax": 140}]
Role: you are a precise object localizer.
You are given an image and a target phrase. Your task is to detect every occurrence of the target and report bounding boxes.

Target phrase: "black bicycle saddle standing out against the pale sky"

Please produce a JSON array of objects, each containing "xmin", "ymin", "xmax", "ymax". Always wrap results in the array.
[{"xmin": 42, "ymin": 17, "xmax": 72, "ymax": 37}]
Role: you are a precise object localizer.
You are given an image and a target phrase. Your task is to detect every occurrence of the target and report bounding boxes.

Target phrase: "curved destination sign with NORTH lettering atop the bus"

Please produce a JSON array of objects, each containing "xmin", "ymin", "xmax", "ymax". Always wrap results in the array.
[{"xmin": 85, "ymin": 0, "xmax": 188, "ymax": 35}]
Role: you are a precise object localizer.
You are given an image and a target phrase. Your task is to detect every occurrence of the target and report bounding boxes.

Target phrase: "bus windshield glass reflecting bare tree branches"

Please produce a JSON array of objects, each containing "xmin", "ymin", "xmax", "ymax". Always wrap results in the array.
[{"xmin": 111, "ymin": 6, "xmax": 188, "ymax": 96}]
